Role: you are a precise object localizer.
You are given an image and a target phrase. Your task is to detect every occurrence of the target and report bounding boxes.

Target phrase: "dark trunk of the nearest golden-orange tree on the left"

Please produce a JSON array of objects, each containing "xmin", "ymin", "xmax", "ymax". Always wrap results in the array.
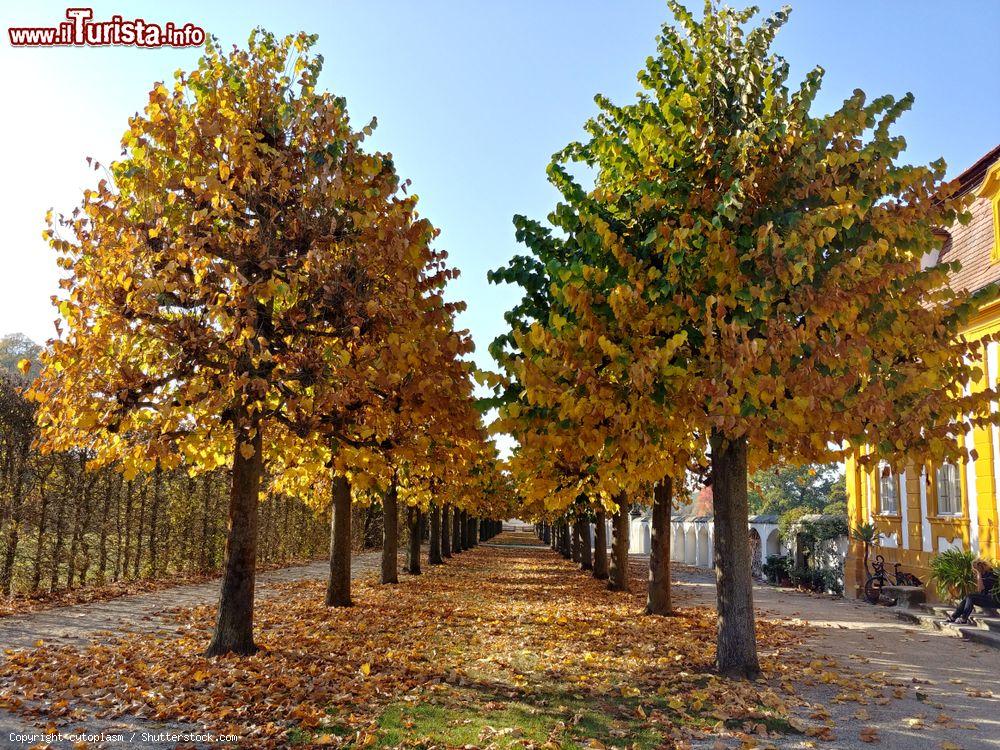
[{"xmin": 205, "ymin": 415, "xmax": 264, "ymax": 656}]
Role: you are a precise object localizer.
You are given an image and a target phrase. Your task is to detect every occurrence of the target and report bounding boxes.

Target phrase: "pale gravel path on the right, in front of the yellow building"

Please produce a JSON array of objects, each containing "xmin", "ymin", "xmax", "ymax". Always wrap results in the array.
[{"xmin": 675, "ymin": 568, "xmax": 1000, "ymax": 750}]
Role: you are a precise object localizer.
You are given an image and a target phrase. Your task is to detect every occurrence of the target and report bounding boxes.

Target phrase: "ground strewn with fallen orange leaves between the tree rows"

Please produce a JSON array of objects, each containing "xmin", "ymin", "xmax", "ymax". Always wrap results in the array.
[{"xmin": 0, "ymin": 536, "xmax": 920, "ymax": 750}]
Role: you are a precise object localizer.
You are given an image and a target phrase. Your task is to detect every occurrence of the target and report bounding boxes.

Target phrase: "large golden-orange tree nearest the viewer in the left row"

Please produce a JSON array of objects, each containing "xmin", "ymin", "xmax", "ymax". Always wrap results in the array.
[{"xmin": 35, "ymin": 31, "xmax": 454, "ymax": 655}]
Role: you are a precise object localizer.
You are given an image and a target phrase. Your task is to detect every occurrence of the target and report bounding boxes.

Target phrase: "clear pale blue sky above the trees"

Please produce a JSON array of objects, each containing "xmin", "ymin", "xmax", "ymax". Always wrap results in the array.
[{"xmin": 0, "ymin": 0, "xmax": 1000, "ymax": 378}]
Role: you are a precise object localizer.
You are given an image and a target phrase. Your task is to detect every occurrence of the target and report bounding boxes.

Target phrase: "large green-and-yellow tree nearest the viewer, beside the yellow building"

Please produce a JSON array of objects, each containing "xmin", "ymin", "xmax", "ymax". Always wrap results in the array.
[{"xmin": 504, "ymin": 3, "xmax": 995, "ymax": 677}]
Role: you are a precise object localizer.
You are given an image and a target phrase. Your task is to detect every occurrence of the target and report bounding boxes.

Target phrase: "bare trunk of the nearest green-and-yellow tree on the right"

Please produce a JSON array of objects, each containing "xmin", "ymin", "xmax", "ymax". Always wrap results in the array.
[{"xmin": 711, "ymin": 432, "xmax": 760, "ymax": 680}]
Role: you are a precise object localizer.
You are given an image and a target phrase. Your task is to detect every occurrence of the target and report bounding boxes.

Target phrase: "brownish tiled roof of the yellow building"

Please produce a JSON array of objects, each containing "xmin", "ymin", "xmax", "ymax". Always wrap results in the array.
[{"xmin": 939, "ymin": 146, "xmax": 1000, "ymax": 292}]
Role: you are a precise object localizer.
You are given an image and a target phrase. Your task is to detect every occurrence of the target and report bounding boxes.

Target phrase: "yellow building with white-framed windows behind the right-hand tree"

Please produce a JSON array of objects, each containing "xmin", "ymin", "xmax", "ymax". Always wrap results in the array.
[{"xmin": 845, "ymin": 146, "xmax": 1000, "ymax": 596}]
